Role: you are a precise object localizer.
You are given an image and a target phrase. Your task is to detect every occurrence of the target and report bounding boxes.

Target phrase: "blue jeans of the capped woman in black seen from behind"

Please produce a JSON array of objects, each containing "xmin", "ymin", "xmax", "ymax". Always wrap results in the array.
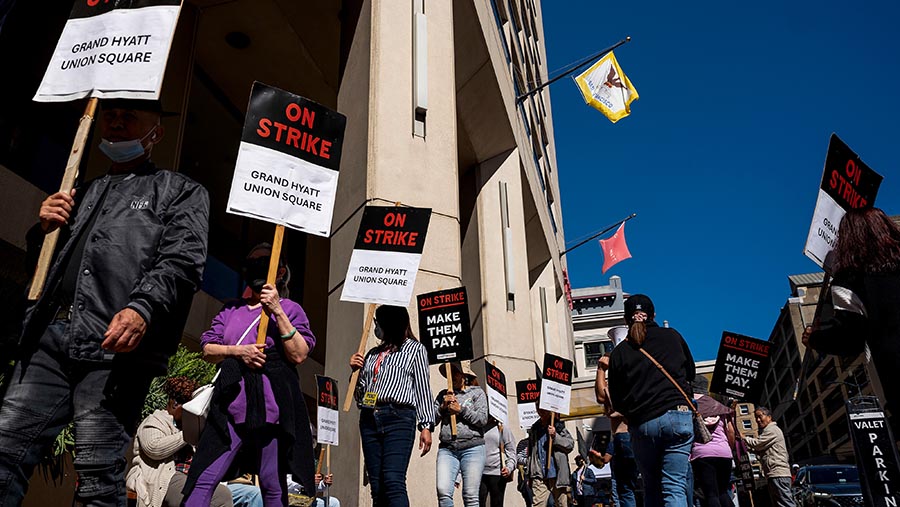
[{"xmin": 632, "ymin": 410, "xmax": 694, "ymax": 507}]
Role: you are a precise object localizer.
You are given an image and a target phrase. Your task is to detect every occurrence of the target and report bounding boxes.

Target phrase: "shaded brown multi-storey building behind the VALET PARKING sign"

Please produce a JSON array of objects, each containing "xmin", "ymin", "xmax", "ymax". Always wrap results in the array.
[{"xmin": 761, "ymin": 273, "xmax": 883, "ymax": 463}]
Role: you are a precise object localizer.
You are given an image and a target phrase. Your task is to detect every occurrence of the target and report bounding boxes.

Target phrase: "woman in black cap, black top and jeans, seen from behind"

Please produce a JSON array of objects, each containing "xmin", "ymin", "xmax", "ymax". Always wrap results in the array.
[{"xmin": 608, "ymin": 294, "xmax": 694, "ymax": 507}]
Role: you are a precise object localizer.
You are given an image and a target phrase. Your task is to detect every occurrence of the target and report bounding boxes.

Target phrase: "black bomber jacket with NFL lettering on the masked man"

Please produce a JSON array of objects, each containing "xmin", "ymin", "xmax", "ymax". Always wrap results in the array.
[{"xmin": 19, "ymin": 162, "xmax": 209, "ymax": 374}]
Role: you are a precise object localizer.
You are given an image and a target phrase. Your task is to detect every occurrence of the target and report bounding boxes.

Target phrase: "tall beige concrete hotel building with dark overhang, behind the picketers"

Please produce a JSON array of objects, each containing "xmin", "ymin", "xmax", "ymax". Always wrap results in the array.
[{"xmin": 0, "ymin": 0, "xmax": 574, "ymax": 505}]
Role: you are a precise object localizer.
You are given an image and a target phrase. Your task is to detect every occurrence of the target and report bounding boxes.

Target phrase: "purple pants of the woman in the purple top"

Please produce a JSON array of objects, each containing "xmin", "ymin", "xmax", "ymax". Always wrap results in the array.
[{"xmin": 184, "ymin": 422, "xmax": 287, "ymax": 507}]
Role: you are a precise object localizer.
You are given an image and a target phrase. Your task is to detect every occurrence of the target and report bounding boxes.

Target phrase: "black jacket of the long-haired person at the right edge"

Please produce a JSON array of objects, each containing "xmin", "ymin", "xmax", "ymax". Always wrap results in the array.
[{"xmin": 809, "ymin": 272, "xmax": 900, "ymax": 418}]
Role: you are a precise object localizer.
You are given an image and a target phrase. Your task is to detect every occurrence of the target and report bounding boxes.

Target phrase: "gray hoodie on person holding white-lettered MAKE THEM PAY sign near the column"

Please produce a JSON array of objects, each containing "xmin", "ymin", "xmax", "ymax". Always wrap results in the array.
[{"xmin": 434, "ymin": 386, "xmax": 488, "ymax": 451}]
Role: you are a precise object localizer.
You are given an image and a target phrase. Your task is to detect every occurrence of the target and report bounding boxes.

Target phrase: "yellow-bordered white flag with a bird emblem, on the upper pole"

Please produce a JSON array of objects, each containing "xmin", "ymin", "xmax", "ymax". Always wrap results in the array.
[{"xmin": 575, "ymin": 51, "xmax": 638, "ymax": 123}]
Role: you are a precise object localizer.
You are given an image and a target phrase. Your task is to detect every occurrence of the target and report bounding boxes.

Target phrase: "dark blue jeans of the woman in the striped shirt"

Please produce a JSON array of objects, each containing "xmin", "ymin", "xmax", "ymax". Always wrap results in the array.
[{"xmin": 359, "ymin": 405, "xmax": 416, "ymax": 507}]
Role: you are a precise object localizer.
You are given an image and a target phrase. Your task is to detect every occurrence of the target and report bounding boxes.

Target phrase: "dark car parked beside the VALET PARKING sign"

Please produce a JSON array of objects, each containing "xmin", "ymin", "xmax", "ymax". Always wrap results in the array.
[{"xmin": 792, "ymin": 465, "xmax": 864, "ymax": 507}]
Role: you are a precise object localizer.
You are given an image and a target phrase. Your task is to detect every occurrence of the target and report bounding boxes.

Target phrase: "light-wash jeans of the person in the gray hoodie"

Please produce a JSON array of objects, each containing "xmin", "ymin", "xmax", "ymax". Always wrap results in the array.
[{"xmin": 437, "ymin": 444, "xmax": 484, "ymax": 507}]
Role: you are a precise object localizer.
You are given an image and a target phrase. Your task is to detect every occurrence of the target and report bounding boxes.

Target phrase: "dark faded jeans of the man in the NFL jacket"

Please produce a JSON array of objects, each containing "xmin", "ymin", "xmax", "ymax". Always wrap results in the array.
[{"xmin": 0, "ymin": 320, "xmax": 152, "ymax": 507}]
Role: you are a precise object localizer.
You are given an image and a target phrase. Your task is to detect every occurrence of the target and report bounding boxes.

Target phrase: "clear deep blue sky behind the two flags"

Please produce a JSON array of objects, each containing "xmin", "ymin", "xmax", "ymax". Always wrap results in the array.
[{"xmin": 542, "ymin": 0, "xmax": 900, "ymax": 360}]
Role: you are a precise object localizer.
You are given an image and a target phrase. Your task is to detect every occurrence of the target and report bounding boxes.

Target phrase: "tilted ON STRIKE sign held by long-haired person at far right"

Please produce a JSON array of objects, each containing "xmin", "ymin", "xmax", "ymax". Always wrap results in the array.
[{"xmin": 805, "ymin": 134, "xmax": 883, "ymax": 268}]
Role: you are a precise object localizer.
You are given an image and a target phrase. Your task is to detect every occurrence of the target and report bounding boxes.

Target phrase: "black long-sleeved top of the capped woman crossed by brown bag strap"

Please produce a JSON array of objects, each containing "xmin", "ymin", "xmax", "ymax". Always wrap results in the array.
[{"xmin": 608, "ymin": 321, "xmax": 695, "ymax": 427}]
